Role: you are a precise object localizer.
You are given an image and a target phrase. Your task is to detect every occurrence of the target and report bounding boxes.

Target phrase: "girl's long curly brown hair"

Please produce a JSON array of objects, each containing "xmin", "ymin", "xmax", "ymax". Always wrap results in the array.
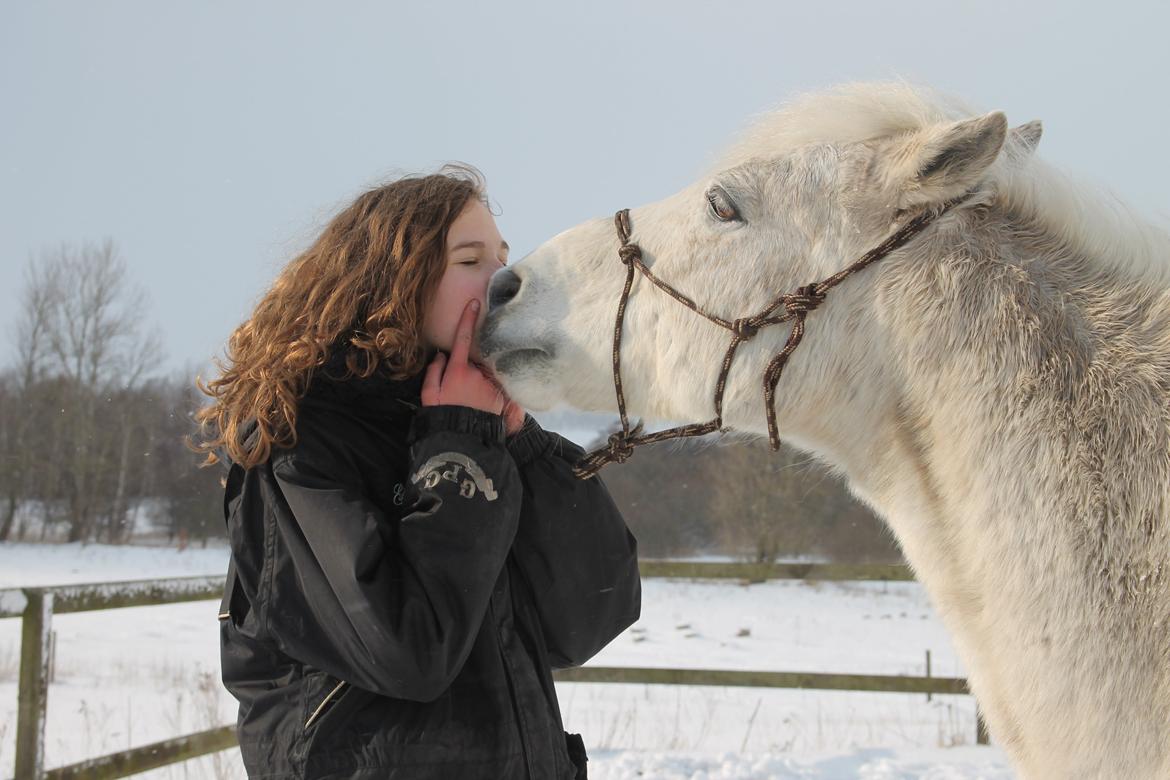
[{"xmin": 192, "ymin": 165, "xmax": 487, "ymax": 469}]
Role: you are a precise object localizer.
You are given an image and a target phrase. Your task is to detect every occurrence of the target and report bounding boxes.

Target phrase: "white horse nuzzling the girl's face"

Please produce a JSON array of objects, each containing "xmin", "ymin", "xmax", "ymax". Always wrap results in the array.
[{"xmin": 481, "ymin": 84, "xmax": 1170, "ymax": 779}]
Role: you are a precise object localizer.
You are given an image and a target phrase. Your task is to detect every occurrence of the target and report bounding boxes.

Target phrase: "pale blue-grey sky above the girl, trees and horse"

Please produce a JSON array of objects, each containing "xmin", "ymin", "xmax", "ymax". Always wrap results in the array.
[{"xmin": 0, "ymin": 0, "xmax": 1170, "ymax": 372}]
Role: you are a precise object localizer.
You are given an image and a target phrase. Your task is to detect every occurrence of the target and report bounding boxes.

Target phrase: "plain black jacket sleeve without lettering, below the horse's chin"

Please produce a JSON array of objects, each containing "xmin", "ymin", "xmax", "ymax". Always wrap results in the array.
[{"xmin": 508, "ymin": 416, "xmax": 641, "ymax": 668}]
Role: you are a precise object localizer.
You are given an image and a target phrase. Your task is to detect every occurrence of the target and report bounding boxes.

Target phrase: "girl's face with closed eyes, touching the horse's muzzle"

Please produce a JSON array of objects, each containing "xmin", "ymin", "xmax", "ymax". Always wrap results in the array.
[{"xmin": 422, "ymin": 200, "xmax": 508, "ymax": 359}]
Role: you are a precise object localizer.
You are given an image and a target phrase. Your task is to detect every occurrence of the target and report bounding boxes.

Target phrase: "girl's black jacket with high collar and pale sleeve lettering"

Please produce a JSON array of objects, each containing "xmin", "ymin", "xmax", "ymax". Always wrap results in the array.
[{"xmin": 220, "ymin": 367, "xmax": 641, "ymax": 780}]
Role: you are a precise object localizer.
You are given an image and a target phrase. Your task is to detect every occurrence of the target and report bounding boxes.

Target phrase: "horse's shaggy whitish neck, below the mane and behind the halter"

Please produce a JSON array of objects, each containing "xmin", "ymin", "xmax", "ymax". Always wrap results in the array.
[{"xmin": 833, "ymin": 210, "xmax": 1170, "ymax": 771}]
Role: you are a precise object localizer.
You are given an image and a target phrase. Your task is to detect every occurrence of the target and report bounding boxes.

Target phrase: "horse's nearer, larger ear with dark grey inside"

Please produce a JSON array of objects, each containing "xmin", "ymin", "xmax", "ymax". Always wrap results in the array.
[{"xmin": 897, "ymin": 111, "xmax": 1007, "ymax": 209}]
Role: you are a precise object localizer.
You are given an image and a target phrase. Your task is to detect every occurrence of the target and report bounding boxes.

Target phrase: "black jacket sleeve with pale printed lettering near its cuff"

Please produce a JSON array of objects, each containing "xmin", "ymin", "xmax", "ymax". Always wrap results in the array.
[{"xmin": 267, "ymin": 406, "xmax": 521, "ymax": 700}]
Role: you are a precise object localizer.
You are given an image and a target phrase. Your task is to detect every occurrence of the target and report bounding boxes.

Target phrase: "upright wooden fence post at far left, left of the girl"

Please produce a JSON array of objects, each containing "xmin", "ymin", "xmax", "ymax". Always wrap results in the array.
[{"xmin": 15, "ymin": 588, "xmax": 53, "ymax": 780}]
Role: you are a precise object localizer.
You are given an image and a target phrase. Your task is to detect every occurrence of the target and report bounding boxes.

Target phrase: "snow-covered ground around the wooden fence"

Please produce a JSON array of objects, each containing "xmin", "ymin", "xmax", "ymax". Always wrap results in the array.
[{"xmin": 0, "ymin": 544, "xmax": 1012, "ymax": 780}]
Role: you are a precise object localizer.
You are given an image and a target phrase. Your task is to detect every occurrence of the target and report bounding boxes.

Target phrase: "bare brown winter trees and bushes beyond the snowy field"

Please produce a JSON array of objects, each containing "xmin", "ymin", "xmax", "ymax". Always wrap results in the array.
[{"xmin": 0, "ymin": 241, "xmax": 900, "ymax": 562}]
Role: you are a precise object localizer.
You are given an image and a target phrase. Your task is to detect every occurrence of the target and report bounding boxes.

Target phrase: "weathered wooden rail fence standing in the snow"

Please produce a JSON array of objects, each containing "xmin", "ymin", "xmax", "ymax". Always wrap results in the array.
[{"xmin": 0, "ymin": 560, "xmax": 987, "ymax": 780}]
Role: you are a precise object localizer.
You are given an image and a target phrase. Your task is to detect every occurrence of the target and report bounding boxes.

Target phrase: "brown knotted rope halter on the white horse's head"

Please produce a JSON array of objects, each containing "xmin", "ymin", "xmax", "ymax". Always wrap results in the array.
[{"xmin": 573, "ymin": 195, "xmax": 970, "ymax": 479}]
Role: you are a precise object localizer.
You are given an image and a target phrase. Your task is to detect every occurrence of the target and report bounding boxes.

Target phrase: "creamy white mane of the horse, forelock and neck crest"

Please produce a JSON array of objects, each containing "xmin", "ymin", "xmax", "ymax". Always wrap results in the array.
[{"xmin": 714, "ymin": 82, "xmax": 1170, "ymax": 285}]
